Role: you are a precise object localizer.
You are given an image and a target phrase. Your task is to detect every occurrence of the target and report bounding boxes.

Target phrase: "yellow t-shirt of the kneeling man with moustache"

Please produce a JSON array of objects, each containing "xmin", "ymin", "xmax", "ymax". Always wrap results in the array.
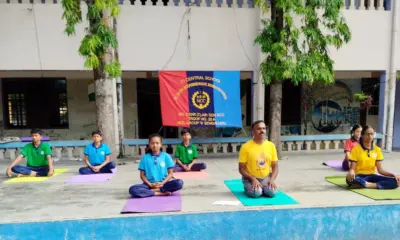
[{"xmin": 239, "ymin": 140, "xmax": 278, "ymax": 178}]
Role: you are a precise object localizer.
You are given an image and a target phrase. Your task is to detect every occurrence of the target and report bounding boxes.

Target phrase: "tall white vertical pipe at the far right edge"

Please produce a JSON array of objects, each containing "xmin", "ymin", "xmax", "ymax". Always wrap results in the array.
[{"xmin": 386, "ymin": 0, "xmax": 400, "ymax": 152}]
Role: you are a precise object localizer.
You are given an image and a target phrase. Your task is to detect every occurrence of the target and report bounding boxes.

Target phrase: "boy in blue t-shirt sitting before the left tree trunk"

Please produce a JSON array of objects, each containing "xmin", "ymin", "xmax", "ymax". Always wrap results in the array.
[{"xmin": 79, "ymin": 131, "xmax": 115, "ymax": 174}]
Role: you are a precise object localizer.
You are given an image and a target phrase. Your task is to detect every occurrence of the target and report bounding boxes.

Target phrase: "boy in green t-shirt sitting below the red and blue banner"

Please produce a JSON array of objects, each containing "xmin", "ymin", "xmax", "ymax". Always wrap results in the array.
[{"xmin": 174, "ymin": 129, "xmax": 207, "ymax": 172}]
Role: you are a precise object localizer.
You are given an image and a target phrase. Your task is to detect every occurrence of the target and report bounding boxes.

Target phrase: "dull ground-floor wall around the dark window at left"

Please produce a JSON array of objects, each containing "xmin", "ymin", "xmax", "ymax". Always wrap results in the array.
[{"xmin": 0, "ymin": 72, "xmax": 141, "ymax": 140}]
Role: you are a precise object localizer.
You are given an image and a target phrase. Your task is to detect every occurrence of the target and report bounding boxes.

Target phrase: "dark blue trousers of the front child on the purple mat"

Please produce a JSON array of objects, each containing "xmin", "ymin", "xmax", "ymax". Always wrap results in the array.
[{"xmin": 129, "ymin": 179, "xmax": 183, "ymax": 198}]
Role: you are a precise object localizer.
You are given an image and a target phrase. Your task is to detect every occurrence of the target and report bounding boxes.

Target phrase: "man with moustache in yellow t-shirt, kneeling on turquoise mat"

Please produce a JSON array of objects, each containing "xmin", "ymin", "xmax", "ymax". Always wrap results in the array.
[{"xmin": 239, "ymin": 120, "xmax": 278, "ymax": 198}]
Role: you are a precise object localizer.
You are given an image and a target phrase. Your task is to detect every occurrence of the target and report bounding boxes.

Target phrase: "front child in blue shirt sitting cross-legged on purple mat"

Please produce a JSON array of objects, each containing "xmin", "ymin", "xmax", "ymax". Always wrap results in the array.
[{"xmin": 129, "ymin": 134, "xmax": 183, "ymax": 198}]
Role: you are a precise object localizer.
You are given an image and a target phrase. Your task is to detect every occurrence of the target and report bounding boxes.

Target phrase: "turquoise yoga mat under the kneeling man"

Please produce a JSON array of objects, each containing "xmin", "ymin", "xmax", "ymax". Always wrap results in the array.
[{"xmin": 224, "ymin": 179, "xmax": 298, "ymax": 206}]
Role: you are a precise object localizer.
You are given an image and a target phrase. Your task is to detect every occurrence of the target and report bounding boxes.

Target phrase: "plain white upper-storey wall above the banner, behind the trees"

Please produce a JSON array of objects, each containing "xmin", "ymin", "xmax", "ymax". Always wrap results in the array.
[{"xmin": 0, "ymin": 4, "xmax": 394, "ymax": 71}]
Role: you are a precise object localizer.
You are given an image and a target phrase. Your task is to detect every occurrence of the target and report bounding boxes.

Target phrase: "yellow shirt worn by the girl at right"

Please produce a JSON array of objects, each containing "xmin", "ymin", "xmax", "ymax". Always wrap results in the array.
[{"xmin": 349, "ymin": 144, "xmax": 383, "ymax": 174}]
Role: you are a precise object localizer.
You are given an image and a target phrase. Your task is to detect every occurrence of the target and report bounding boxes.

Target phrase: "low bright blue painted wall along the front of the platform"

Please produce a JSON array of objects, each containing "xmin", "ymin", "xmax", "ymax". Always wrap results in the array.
[{"xmin": 0, "ymin": 204, "xmax": 400, "ymax": 240}]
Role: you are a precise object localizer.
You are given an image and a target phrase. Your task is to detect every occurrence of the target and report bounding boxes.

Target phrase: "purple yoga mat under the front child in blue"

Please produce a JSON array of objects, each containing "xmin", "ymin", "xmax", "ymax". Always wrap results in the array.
[{"xmin": 121, "ymin": 192, "xmax": 182, "ymax": 213}]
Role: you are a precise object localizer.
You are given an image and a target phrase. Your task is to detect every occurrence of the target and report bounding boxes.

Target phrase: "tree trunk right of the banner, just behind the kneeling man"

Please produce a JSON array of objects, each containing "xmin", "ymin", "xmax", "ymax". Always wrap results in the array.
[{"xmin": 268, "ymin": 81, "xmax": 282, "ymax": 159}]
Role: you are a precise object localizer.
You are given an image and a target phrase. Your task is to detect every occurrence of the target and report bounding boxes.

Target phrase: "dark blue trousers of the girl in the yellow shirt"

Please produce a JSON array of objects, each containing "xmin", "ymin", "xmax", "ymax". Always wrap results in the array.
[{"xmin": 346, "ymin": 174, "xmax": 398, "ymax": 189}]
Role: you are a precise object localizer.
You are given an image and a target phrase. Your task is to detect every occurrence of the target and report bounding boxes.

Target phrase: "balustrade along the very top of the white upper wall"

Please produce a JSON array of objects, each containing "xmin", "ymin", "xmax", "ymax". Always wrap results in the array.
[{"xmin": 0, "ymin": 0, "xmax": 394, "ymax": 11}]
